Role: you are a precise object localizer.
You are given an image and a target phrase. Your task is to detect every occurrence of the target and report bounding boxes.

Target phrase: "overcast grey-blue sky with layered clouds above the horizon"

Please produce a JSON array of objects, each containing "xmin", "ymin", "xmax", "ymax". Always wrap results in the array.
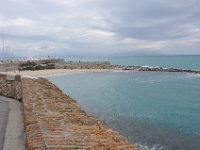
[{"xmin": 0, "ymin": 0, "xmax": 200, "ymax": 57}]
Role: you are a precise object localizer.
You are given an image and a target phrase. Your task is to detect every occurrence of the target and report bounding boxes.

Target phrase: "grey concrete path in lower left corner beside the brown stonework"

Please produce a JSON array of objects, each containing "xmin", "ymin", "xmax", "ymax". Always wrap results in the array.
[{"xmin": 0, "ymin": 96, "xmax": 24, "ymax": 150}]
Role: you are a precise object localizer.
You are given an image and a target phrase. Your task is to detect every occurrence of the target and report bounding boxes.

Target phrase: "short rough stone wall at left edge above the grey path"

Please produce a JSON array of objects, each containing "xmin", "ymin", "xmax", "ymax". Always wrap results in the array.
[{"xmin": 0, "ymin": 74, "xmax": 22, "ymax": 100}]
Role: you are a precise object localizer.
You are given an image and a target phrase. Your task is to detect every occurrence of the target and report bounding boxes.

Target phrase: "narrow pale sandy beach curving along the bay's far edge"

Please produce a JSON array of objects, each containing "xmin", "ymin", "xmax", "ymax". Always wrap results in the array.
[{"xmin": 1, "ymin": 69, "xmax": 112, "ymax": 77}]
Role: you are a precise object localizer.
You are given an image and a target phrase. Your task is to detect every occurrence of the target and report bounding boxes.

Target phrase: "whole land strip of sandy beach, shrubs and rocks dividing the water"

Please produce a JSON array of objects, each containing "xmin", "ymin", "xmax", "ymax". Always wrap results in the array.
[{"xmin": 0, "ymin": 59, "xmax": 200, "ymax": 77}]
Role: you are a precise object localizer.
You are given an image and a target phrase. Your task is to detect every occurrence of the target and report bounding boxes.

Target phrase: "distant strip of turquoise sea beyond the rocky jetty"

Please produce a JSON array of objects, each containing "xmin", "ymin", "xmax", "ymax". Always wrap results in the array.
[{"xmin": 66, "ymin": 56, "xmax": 200, "ymax": 70}]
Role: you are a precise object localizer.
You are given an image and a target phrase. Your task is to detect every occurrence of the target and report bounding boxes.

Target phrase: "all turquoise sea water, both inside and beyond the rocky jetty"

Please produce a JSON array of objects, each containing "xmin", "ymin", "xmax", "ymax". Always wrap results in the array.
[{"xmin": 46, "ymin": 56, "xmax": 200, "ymax": 150}]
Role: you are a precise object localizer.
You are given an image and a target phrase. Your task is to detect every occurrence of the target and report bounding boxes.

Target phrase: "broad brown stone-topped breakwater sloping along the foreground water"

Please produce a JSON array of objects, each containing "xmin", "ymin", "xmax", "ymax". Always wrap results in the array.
[{"xmin": 22, "ymin": 78, "xmax": 136, "ymax": 150}]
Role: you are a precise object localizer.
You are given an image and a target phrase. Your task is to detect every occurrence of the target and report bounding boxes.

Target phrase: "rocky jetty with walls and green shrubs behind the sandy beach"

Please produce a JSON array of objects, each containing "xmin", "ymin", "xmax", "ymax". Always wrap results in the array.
[{"xmin": 0, "ymin": 59, "xmax": 200, "ymax": 74}]
